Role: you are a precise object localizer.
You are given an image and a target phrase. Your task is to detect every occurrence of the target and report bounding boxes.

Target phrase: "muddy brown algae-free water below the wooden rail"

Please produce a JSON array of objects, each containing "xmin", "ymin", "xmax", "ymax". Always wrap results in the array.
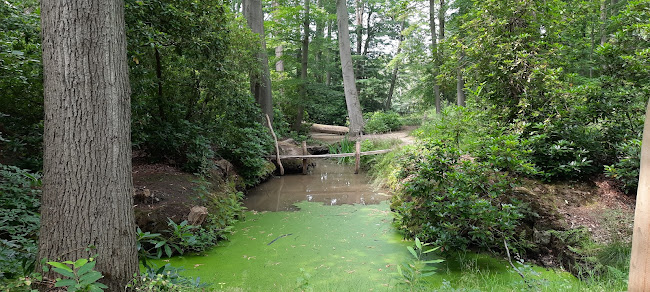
[{"xmin": 244, "ymin": 159, "xmax": 390, "ymax": 211}]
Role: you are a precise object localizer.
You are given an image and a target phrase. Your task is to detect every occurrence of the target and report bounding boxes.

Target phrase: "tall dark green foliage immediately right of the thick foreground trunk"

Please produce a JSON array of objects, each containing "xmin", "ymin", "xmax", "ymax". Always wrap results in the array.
[{"xmin": 125, "ymin": 0, "xmax": 271, "ymax": 184}]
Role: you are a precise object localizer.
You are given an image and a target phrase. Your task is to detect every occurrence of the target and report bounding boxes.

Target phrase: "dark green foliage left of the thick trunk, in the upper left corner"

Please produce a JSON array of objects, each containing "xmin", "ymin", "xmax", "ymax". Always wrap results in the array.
[{"xmin": 0, "ymin": 1, "xmax": 43, "ymax": 171}]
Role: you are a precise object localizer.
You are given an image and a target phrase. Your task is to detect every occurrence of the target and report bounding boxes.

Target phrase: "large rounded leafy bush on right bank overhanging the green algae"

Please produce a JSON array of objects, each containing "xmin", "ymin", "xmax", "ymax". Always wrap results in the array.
[{"xmin": 391, "ymin": 140, "xmax": 523, "ymax": 251}]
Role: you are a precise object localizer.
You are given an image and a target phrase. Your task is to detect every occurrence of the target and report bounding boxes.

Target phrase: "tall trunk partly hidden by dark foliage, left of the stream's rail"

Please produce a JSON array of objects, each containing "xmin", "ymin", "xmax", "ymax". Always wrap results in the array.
[{"xmin": 242, "ymin": 0, "xmax": 273, "ymax": 121}]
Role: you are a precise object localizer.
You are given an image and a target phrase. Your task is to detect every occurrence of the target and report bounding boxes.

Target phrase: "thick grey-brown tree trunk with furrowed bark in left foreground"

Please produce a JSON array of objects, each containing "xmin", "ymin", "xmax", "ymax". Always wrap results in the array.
[{"xmin": 38, "ymin": 0, "xmax": 139, "ymax": 291}]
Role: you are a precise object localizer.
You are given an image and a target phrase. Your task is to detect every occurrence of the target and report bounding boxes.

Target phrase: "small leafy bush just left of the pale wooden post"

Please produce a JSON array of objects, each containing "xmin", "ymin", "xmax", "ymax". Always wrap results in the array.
[{"xmin": 605, "ymin": 139, "xmax": 641, "ymax": 194}]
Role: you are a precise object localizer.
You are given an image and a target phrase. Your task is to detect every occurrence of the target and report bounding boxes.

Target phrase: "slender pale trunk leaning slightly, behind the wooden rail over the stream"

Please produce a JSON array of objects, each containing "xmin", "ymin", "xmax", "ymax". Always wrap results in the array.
[{"xmin": 336, "ymin": 0, "xmax": 364, "ymax": 137}]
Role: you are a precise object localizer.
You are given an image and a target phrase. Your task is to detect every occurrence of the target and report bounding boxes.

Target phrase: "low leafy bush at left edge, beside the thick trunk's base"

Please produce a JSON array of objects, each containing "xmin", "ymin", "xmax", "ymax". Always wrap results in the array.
[{"xmin": 0, "ymin": 164, "xmax": 41, "ymax": 279}]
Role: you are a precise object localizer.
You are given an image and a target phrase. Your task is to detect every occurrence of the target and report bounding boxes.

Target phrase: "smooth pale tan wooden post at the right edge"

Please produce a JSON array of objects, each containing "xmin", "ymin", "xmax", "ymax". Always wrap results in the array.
[{"xmin": 627, "ymin": 103, "xmax": 650, "ymax": 291}]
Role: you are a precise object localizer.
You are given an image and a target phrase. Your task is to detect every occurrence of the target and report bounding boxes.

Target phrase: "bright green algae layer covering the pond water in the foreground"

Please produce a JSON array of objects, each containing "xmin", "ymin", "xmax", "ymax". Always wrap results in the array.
[{"xmin": 158, "ymin": 162, "xmax": 579, "ymax": 291}]
